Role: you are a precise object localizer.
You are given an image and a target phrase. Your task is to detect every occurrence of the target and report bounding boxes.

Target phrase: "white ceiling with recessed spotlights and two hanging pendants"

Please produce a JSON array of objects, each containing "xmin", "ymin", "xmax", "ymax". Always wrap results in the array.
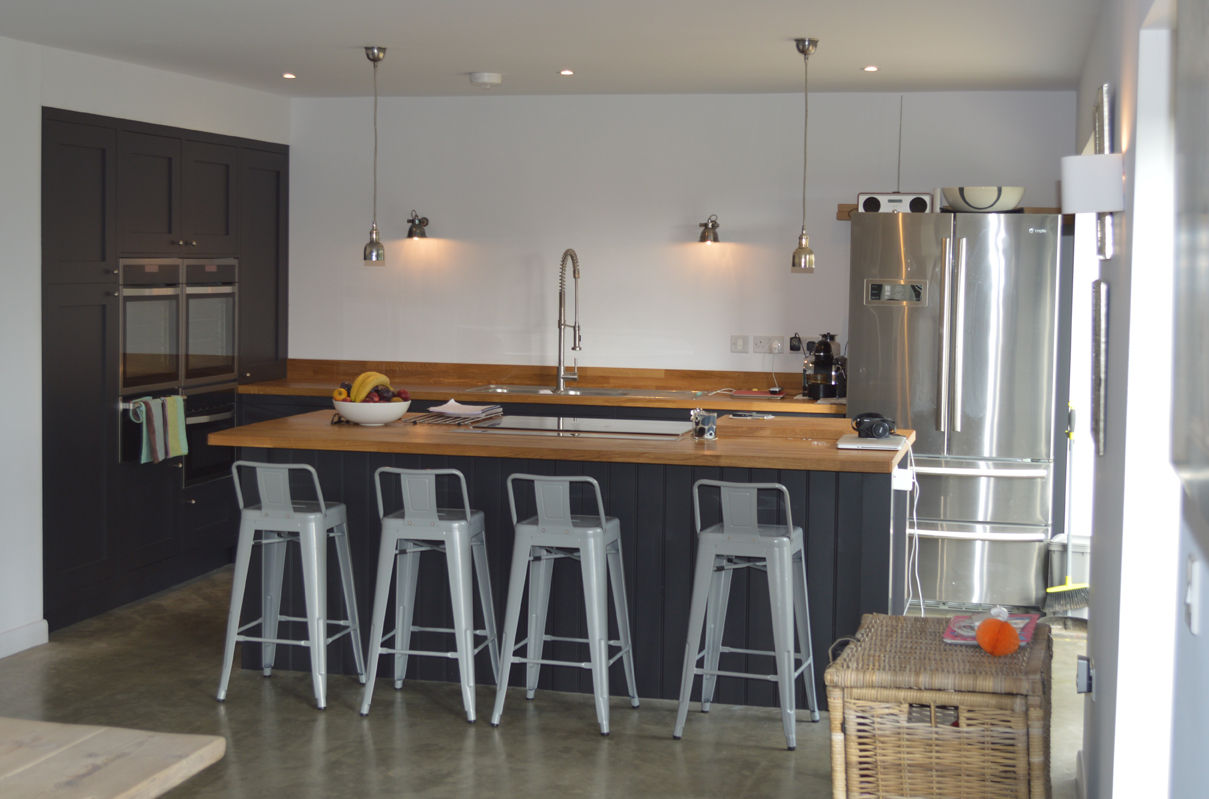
[{"xmin": 0, "ymin": 0, "xmax": 1100, "ymax": 97}]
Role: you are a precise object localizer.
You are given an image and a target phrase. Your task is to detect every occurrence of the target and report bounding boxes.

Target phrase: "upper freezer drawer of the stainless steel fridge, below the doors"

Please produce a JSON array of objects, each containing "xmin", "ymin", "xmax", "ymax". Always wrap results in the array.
[{"xmin": 915, "ymin": 458, "xmax": 1053, "ymax": 525}]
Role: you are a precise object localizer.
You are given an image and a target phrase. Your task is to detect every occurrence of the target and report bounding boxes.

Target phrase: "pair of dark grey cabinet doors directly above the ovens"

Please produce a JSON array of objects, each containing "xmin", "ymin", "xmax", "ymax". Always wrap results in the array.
[{"xmin": 117, "ymin": 129, "xmax": 239, "ymax": 257}]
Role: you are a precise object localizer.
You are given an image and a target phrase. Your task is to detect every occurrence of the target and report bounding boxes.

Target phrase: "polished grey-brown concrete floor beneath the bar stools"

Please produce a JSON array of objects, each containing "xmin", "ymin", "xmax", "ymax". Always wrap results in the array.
[{"xmin": 0, "ymin": 569, "xmax": 1086, "ymax": 799}]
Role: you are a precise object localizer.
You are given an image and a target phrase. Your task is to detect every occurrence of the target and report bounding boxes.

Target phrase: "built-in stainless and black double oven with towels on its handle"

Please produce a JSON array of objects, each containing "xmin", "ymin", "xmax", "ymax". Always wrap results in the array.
[{"xmin": 117, "ymin": 257, "xmax": 239, "ymax": 486}]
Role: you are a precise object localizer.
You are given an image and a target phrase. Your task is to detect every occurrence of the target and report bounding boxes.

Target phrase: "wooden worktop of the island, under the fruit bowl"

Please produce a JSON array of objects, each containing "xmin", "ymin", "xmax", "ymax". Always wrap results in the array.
[{"xmin": 208, "ymin": 411, "xmax": 915, "ymax": 474}]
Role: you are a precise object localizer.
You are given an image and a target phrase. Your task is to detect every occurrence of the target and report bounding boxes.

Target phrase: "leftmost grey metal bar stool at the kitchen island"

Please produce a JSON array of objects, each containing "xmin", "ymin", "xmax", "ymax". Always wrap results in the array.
[{"xmin": 218, "ymin": 461, "xmax": 365, "ymax": 710}]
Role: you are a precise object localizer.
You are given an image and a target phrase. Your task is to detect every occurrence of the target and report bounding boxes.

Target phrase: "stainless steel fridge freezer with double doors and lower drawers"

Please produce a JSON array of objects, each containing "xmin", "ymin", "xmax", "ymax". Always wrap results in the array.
[{"xmin": 848, "ymin": 213, "xmax": 1062, "ymax": 606}]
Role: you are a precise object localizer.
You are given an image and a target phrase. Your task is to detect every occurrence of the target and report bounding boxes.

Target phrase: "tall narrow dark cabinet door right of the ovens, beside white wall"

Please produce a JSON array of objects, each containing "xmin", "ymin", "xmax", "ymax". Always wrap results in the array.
[{"xmin": 238, "ymin": 146, "xmax": 289, "ymax": 383}]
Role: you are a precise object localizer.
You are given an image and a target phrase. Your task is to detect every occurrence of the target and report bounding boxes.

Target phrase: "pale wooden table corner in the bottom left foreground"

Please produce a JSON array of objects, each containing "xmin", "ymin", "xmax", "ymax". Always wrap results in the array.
[{"xmin": 0, "ymin": 718, "xmax": 226, "ymax": 799}]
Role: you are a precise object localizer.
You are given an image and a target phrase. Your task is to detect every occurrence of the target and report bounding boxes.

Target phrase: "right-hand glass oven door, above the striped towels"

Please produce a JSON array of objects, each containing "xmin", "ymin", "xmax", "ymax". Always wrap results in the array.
[{"xmin": 185, "ymin": 285, "xmax": 238, "ymax": 386}]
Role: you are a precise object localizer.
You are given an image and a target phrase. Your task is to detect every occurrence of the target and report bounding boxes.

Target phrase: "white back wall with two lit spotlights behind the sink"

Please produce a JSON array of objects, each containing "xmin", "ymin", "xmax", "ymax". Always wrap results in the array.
[{"xmin": 290, "ymin": 92, "xmax": 1075, "ymax": 371}]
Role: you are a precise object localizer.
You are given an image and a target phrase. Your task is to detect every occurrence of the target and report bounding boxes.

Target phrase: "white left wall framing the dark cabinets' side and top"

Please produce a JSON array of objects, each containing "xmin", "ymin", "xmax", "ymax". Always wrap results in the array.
[{"xmin": 0, "ymin": 37, "xmax": 289, "ymax": 656}]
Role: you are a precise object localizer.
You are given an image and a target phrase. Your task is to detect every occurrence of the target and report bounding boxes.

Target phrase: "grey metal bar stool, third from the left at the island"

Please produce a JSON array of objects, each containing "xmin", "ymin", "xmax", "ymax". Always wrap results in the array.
[{"xmin": 491, "ymin": 474, "xmax": 638, "ymax": 735}]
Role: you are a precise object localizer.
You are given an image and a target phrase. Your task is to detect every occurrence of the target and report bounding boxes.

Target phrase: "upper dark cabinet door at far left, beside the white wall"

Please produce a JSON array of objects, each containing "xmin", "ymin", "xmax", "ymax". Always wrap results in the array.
[{"xmin": 42, "ymin": 109, "xmax": 117, "ymax": 286}]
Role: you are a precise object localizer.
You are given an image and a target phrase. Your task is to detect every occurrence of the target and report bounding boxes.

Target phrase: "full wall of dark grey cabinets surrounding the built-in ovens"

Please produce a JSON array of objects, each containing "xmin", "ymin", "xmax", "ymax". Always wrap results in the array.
[{"xmin": 41, "ymin": 108, "xmax": 289, "ymax": 629}]
